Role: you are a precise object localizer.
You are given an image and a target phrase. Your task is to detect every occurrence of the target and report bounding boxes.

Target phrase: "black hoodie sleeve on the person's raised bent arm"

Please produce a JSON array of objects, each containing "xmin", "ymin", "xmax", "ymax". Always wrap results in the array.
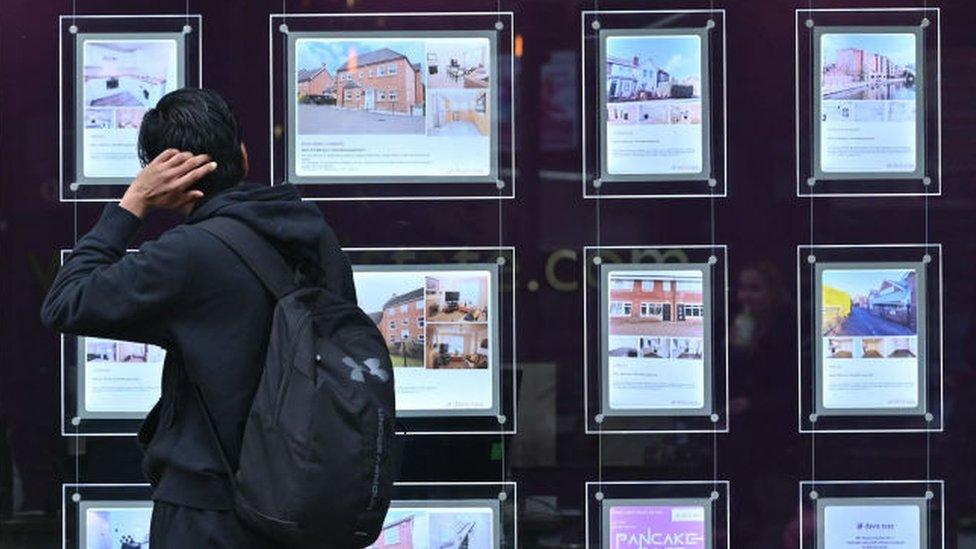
[{"xmin": 41, "ymin": 204, "xmax": 190, "ymax": 345}]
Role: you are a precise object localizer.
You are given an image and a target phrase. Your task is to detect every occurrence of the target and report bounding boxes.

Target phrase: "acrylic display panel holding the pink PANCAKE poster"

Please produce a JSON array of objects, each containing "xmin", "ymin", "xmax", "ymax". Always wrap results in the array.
[{"xmin": 586, "ymin": 480, "xmax": 729, "ymax": 549}]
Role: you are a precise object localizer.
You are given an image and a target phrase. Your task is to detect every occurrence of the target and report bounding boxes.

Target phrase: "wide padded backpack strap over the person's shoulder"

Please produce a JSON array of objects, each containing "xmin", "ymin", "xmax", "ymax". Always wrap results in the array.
[{"xmin": 193, "ymin": 217, "xmax": 297, "ymax": 299}]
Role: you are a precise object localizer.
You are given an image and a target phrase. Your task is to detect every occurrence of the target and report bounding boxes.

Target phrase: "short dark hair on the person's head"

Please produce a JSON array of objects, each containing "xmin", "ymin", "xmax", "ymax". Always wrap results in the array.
[{"xmin": 139, "ymin": 88, "xmax": 245, "ymax": 195}]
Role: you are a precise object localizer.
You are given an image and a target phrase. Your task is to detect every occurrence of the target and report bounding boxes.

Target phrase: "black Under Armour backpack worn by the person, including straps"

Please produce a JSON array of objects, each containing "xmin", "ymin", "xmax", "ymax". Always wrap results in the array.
[{"xmin": 195, "ymin": 217, "xmax": 399, "ymax": 548}]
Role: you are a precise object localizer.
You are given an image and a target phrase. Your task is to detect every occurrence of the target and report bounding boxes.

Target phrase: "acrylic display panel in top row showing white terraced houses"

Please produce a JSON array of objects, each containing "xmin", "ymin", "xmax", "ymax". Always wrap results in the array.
[{"xmin": 582, "ymin": 10, "xmax": 726, "ymax": 198}]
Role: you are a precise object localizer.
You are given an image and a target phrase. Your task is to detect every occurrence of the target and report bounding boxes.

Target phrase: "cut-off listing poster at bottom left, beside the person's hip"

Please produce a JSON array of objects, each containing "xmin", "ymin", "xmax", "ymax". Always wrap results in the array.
[{"xmin": 81, "ymin": 502, "xmax": 152, "ymax": 549}]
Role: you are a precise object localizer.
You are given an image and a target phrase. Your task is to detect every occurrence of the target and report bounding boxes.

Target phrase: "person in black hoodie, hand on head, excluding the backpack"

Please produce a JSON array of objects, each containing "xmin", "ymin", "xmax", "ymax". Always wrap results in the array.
[{"xmin": 41, "ymin": 89, "xmax": 356, "ymax": 549}]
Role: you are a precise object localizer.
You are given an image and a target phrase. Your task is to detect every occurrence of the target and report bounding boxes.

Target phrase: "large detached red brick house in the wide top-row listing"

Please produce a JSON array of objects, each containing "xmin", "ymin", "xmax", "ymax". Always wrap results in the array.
[{"xmin": 336, "ymin": 48, "xmax": 424, "ymax": 115}]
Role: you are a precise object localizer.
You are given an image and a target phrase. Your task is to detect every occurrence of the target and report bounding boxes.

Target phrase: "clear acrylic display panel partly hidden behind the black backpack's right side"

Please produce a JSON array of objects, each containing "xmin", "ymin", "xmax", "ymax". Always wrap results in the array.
[{"xmin": 346, "ymin": 248, "xmax": 515, "ymax": 434}]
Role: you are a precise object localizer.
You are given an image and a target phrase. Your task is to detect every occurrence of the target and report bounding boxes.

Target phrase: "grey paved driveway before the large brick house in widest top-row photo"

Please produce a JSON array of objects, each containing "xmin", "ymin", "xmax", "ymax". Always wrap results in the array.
[{"xmin": 298, "ymin": 105, "xmax": 425, "ymax": 135}]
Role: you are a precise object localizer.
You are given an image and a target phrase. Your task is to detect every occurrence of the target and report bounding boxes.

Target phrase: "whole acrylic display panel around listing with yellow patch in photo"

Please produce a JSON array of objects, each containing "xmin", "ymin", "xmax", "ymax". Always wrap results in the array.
[{"xmin": 797, "ymin": 245, "xmax": 942, "ymax": 432}]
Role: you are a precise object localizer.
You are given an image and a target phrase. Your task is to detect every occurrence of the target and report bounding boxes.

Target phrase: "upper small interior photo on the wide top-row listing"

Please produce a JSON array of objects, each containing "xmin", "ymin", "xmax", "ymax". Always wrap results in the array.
[{"xmin": 427, "ymin": 38, "xmax": 491, "ymax": 89}]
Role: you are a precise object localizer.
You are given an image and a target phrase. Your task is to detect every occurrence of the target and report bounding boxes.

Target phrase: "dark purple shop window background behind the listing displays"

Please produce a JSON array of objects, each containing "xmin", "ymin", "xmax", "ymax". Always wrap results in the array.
[{"xmin": 0, "ymin": 0, "xmax": 976, "ymax": 549}]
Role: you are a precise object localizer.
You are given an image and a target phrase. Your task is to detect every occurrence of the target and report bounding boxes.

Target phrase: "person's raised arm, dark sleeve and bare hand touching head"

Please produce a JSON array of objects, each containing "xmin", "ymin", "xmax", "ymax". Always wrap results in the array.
[{"xmin": 41, "ymin": 149, "xmax": 216, "ymax": 344}]
